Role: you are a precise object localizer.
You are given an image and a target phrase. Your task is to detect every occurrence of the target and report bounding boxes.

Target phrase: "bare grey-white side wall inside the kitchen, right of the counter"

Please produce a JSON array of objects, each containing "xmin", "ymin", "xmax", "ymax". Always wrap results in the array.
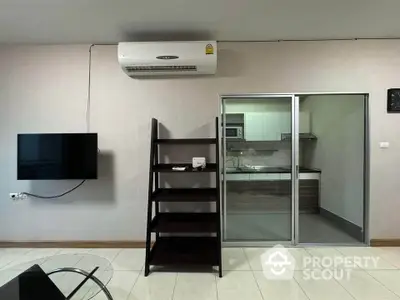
[{"xmin": 300, "ymin": 95, "xmax": 364, "ymax": 227}]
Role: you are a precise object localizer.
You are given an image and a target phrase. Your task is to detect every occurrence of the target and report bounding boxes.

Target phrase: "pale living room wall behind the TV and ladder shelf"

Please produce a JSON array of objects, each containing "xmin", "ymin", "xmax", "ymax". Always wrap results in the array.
[{"xmin": 0, "ymin": 41, "xmax": 400, "ymax": 240}]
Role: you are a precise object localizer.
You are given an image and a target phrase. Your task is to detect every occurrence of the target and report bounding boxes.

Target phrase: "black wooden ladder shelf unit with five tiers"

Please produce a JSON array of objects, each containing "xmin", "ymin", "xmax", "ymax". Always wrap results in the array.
[{"xmin": 145, "ymin": 118, "xmax": 222, "ymax": 277}]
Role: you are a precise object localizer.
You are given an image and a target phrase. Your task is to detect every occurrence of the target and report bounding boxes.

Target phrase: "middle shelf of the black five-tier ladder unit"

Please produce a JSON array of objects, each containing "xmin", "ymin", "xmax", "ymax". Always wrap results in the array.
[{"xmin": 152, "ymin": 188, "xmax": 218, "ymax": 202}]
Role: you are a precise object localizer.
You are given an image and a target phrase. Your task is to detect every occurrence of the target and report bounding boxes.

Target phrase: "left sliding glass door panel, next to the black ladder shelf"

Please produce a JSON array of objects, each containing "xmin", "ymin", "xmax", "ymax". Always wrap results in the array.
[{"xmin": 222, "ymin": 95, "xmax": 298, "ymax": 243}]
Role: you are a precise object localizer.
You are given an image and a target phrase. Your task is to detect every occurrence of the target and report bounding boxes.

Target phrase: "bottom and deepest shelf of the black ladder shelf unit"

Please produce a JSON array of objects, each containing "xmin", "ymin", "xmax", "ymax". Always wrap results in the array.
[{"xmin": 150, "ymin": 237, "xmax": 219, "ymax": 266}]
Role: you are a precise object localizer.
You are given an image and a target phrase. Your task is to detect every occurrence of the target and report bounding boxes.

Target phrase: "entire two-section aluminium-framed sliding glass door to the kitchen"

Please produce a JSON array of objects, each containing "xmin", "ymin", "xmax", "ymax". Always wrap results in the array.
[{"xmin": 221, "ymin": 94, "xmax": 367, "ymax": 246}]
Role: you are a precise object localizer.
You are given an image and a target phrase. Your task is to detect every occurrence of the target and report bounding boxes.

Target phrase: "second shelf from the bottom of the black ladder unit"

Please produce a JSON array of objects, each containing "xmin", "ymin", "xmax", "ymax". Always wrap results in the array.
[{"xmin": 150, "ymin": 213, "xmax": 218, "ymax": 233}]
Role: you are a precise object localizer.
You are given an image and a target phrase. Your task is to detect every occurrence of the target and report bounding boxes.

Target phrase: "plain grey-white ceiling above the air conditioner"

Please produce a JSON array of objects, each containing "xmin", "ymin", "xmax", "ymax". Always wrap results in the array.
[{"xmin": 0, "ymin": 0, "xmax": 400, "ymax": 44}]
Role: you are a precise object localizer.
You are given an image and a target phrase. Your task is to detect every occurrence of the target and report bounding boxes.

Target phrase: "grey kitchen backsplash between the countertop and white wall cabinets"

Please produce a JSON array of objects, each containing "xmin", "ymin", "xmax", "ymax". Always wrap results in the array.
[{"xmin": 226, "ymin": 141, "xmax": 302, "ymax": 167}]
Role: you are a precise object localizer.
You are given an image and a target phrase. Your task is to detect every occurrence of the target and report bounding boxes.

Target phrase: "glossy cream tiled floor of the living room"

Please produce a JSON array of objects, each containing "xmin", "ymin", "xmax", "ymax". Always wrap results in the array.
[{"xmin": 0, "ymin": 247, "xmax": 400, "ymax": 300}]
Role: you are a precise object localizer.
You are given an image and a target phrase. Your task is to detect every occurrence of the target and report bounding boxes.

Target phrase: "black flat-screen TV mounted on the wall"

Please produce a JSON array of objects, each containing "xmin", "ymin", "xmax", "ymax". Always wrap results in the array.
[{"xmin": 18, "ymin": 133, "xmax": 98, "ymax": 180}]
